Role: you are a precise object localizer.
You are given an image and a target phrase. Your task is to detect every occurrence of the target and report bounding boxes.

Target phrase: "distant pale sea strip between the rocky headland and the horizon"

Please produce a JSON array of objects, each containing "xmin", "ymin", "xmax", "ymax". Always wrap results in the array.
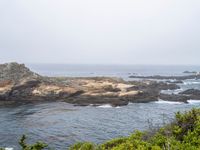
[{"xmin": 27, "ymin": 64, "xmax": 200, "ymax": 79}]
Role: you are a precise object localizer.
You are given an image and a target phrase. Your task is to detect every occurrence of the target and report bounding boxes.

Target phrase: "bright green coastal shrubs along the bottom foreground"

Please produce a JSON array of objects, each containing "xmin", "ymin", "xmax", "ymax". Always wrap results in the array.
[{"xmin": 1, "ymin": 109, "xmax": 200, "ymax": 150}]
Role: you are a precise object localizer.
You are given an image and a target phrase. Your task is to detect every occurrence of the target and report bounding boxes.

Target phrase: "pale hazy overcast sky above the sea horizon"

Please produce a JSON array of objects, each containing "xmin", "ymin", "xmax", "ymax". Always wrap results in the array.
[{"xmin": 0, "ymin": 0, "xmax": 200, "ymax": 65}]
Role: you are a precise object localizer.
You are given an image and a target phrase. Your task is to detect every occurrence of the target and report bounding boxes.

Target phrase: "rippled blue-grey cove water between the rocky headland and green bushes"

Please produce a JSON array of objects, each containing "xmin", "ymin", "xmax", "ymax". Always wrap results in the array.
[{"xmin": 0, "ymin": 102, "xmax": 200, "ymax": 150}]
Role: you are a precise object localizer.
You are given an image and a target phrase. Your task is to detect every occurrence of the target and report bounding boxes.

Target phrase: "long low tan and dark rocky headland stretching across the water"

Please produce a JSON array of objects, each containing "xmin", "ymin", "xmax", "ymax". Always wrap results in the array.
[{"xmin": 0, "ymin": 63, "xmax": 200, "ymax": 106}]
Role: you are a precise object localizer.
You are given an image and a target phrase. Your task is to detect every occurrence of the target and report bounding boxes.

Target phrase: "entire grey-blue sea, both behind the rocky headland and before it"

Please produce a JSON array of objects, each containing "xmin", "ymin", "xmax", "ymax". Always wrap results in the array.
[{"xmin": 0, "ymin": 64, "xmax": 200, "ymax": 150}]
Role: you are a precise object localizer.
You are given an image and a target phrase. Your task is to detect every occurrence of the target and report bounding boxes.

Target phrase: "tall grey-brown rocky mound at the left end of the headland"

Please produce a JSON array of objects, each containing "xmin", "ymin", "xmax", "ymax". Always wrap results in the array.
[{"xmin": 0, "ymin": 63, "xmax": 81, "ymax": 102}]
